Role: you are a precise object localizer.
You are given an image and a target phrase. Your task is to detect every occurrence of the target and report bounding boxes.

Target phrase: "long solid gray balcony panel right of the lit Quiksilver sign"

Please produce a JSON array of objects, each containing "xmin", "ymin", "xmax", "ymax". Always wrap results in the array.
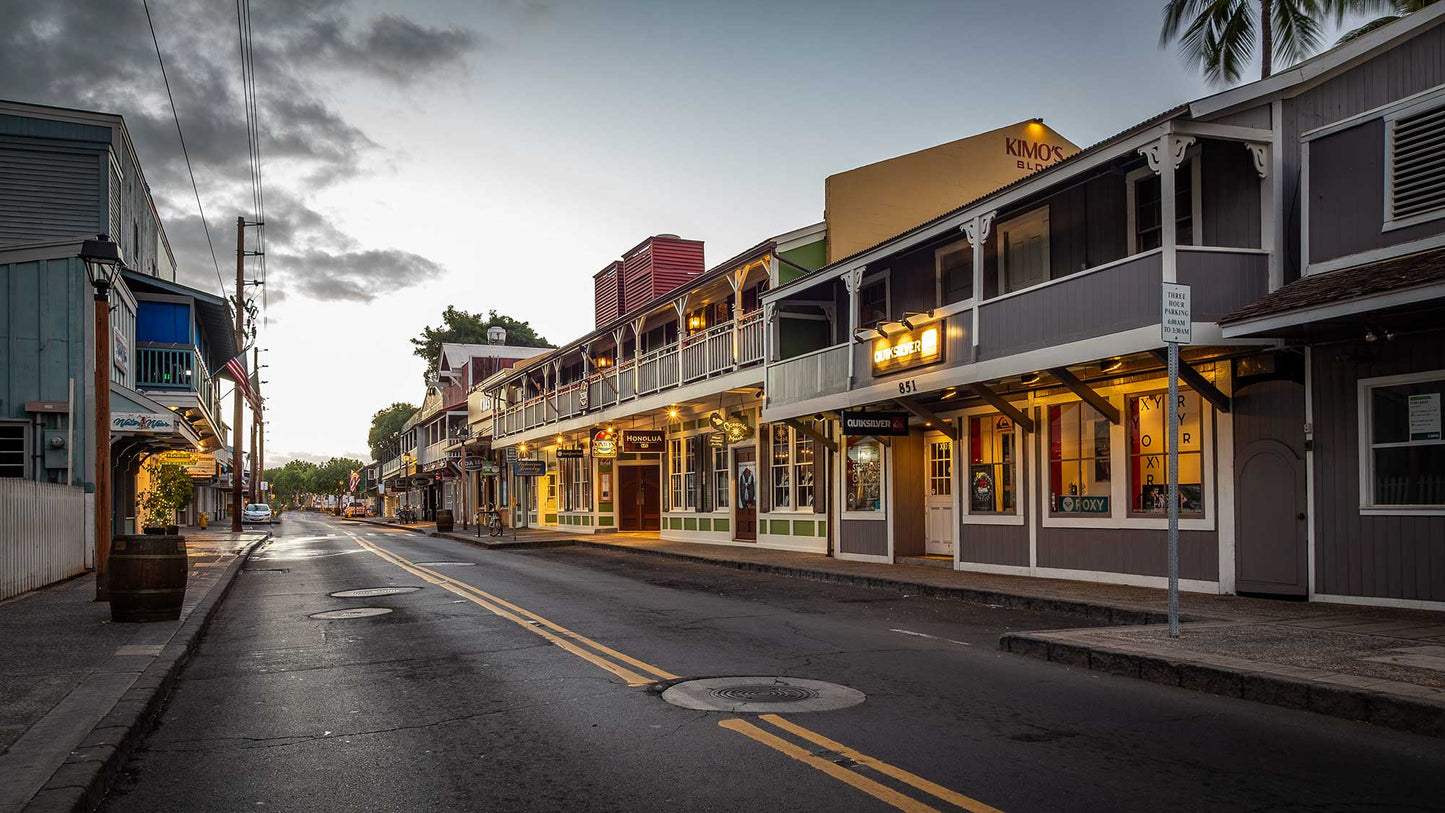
[{"xmin": 978, "ymin": 253, "xmax": 1162, "ymax": 358}]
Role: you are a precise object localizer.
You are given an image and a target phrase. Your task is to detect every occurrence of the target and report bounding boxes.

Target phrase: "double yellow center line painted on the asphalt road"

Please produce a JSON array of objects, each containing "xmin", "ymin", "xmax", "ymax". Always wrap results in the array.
[{"xmin": 347, "ymin": 533, "xmax": 1003, "ymax": 813}]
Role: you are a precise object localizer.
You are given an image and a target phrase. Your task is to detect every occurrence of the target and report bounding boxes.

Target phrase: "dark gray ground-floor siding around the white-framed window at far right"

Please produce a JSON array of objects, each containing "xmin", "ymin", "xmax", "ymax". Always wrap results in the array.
[{"xmin": 1311, "ymin": 332, "xmax": 1445, "ymax": 601}]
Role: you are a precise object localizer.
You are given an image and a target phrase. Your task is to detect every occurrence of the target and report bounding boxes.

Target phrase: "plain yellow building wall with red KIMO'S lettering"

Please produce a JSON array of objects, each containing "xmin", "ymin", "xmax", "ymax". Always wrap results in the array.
[{"xmin": 824, "ymin": 120, "xmax": 1079, "ymax": 263}]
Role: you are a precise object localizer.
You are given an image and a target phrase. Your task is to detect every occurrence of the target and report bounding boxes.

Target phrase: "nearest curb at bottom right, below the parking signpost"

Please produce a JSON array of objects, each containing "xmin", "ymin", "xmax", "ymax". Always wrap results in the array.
[{"xmin": 998, "ymin": 632, "xmax": 1445, "ymax": 736}]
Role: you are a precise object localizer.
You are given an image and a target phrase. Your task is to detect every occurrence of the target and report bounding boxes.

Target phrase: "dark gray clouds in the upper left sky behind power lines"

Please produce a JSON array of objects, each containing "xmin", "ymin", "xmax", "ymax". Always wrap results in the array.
[{"xmin": 0, "ymin": 0, "xmax": 487, "ymax": 303}]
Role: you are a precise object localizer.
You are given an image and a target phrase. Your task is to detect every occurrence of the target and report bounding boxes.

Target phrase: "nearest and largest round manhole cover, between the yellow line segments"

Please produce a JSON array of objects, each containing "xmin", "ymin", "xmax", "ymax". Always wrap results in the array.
[{"xmin": 662, "ymin": 677, "xmax": 867, "ymax": 713}]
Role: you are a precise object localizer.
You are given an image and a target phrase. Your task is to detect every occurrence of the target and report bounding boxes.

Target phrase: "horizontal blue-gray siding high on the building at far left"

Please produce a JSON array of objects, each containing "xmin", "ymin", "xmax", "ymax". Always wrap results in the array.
[{"xmin": 0, "ymin": 146, "xmax": 105, "ymax": 244}]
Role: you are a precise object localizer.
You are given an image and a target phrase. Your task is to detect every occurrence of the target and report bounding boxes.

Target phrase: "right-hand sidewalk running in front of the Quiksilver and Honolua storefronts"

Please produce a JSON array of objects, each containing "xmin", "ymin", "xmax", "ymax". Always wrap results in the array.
[{"xmin": 410, "ymin": 529, "xmax": 1445, "ymax": 736}]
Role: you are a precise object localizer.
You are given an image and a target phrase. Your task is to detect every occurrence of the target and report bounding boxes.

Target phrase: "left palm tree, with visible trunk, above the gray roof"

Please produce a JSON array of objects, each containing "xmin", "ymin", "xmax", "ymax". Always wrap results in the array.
[{"xmin": 1159, "ymin": 0, "xmax": 1329, "ymax": 85}]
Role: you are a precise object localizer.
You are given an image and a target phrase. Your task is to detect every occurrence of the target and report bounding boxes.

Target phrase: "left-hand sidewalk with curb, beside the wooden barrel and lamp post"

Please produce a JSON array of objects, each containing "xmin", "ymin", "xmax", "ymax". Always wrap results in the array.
[{"xmin": 0, "ymin": 529, "xmax": 269, "ymax": 813}]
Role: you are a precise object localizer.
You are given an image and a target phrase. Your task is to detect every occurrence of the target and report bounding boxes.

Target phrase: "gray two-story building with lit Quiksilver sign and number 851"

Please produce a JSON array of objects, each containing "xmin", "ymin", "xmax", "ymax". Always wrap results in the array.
[{"xmin": 763, "ymin": 9, "xmax": 1445, "ymax": 612}]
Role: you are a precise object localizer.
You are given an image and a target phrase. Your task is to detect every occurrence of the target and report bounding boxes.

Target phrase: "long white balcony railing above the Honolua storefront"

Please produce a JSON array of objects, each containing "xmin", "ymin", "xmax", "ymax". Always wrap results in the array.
[{"xmin": 493, "ymin": 310, "xmax": 763, "ymax": 438}]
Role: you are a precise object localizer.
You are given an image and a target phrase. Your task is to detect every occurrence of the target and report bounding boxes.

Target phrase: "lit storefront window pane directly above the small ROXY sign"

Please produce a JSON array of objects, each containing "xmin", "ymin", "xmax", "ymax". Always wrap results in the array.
[{"xmin": 1049, "ymin": 401, "xmax": 1113, "ymax": 516}]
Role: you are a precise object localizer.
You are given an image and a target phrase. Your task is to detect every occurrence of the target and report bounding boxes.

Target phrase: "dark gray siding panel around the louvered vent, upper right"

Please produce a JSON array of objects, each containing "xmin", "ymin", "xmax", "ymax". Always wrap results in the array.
[{"xmin": 1305, "ymin": 118, "xmax": 1445, "ymax": 263}]
